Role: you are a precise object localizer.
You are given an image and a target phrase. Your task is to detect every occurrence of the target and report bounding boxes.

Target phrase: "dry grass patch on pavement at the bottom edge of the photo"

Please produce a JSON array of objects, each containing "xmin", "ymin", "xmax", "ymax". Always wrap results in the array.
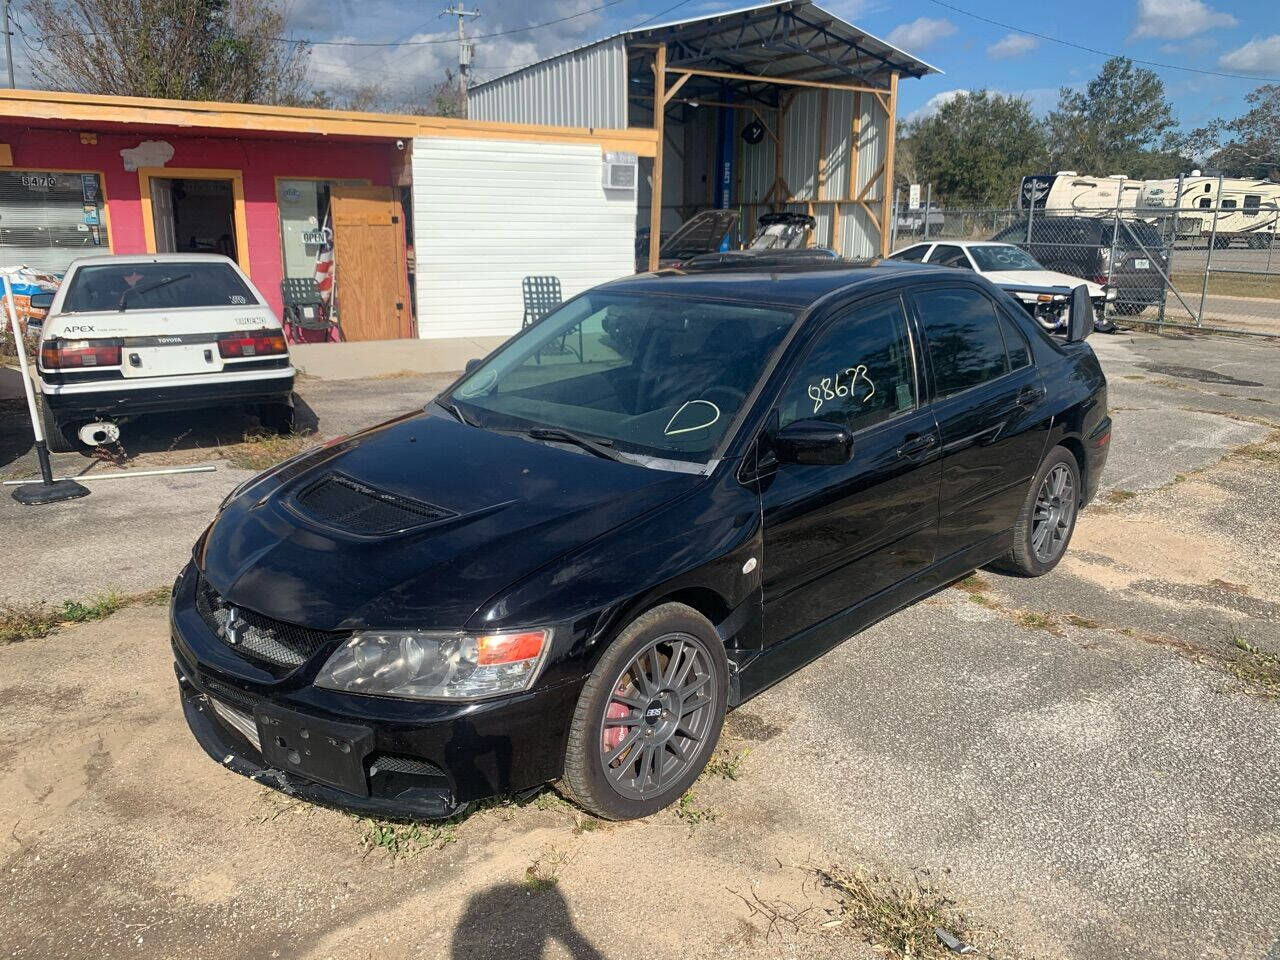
[{"xmin": 815, "ymin": 867, "xmax": 973, "ymax": 960}]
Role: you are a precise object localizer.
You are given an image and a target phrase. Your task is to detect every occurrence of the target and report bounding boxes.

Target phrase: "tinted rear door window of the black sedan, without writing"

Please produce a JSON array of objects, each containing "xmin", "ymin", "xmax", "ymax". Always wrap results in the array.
[{"xmin": 915, "ymin": 287, "xmax": 1009, "ymax": 398}]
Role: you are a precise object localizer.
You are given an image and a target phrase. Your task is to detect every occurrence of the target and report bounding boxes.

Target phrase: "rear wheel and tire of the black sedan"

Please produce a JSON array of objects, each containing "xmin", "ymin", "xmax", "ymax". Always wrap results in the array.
[{"xmin": 992, "ymin": 447, "xmax": 1084, "ymax": 577}]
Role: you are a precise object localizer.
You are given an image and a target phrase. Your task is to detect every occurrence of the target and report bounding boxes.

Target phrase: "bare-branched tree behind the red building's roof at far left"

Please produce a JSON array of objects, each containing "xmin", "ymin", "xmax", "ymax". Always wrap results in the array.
[{"xmin": 27, "ymin": 0, "xmax": 312, "ymax": 104}]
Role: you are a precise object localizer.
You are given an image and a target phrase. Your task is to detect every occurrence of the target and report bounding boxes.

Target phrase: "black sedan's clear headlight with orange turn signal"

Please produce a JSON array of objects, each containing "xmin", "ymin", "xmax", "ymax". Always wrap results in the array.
[{"xmin": 315, "ymin": 630, "xmax": 552, "ymax": 700}]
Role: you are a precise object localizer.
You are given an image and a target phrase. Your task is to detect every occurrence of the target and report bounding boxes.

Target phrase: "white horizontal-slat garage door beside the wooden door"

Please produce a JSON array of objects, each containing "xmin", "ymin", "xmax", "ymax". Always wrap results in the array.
[{"xmin": 413, "ymin": 137, "xmax": 636, "ymax": 339}]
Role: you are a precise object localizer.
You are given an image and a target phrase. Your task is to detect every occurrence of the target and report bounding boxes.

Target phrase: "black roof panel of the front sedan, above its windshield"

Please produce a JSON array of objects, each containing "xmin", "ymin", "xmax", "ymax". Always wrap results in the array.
[{"xmin": 598, "ymin": 260, "xmax": 956, "ymax": 307}]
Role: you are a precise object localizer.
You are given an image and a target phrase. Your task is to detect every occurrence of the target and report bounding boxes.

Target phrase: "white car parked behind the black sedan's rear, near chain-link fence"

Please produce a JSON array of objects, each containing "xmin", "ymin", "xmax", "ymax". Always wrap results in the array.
[{"xmin": 890, "ymin": 239, "xmax": 1116, "ymax": 330}]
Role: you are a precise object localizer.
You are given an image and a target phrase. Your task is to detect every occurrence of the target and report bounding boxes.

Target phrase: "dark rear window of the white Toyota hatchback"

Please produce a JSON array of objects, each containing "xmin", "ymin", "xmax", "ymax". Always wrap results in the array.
[{"xmin": 63, "ymin": 260, "xmax": 259, "ymax": 314}]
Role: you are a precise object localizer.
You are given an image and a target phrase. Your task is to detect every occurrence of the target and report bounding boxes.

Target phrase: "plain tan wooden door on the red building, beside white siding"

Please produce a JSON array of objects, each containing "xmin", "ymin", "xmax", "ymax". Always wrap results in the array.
[{"xmin": 329, "ymin": 186, "xmax": 413, "ymax": 340}]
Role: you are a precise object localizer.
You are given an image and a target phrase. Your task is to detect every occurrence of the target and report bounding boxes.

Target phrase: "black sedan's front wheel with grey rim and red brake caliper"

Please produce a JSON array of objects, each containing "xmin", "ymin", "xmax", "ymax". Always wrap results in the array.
[{"xmin": 559, "ymin": 603, "xmax": 728, "ymax": 820}]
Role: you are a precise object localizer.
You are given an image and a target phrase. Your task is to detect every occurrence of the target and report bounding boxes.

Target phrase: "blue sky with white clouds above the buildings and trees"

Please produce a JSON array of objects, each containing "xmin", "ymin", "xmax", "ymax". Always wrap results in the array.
[{"xmin": 2, "ymin": 0, "xmax": 1280, "ymax": 128}]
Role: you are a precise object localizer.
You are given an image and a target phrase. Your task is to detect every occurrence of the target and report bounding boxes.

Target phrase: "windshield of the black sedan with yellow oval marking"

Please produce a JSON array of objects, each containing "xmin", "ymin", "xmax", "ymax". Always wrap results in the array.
[{"xmin": 449, "ymin": 291, "xmax": 795, "ymax": 463}]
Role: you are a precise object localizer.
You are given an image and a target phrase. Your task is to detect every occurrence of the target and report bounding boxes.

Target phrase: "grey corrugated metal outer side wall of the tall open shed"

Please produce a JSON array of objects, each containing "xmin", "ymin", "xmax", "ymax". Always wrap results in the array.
[{"xmin": 467, "ymin": 37, "xmax": 627, "ymax": 129}]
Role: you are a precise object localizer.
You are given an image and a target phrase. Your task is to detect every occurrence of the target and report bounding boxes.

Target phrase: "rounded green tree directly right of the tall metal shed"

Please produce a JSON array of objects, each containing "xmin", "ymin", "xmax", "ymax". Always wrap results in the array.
[{"xmin": 905, "ymin": 90, "xmax": 1046, "ymax": 206}]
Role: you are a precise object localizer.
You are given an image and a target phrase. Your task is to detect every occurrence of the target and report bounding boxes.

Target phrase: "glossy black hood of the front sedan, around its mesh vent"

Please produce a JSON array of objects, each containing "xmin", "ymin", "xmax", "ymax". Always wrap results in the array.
[{"xmin": 197, "ymin": 412, "xmax": 704, "ymax": 630}]
